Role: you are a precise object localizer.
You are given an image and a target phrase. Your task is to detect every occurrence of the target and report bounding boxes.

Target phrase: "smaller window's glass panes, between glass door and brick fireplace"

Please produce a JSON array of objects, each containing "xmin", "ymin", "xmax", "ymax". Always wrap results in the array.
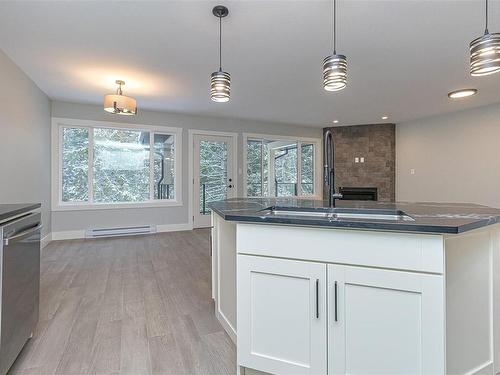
[{"xmin": 244, "ymin": 136, "xmax": 318, "ymax": 197}]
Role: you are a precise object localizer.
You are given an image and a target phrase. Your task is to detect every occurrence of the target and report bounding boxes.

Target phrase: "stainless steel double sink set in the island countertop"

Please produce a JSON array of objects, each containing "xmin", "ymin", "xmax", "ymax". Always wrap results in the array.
[{"xmin": 260, "ymin": 206, "xmax": 415, "ymax": 221}]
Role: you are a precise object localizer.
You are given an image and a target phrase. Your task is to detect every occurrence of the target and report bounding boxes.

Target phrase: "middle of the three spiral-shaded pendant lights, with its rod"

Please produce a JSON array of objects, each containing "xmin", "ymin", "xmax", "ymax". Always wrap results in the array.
[{"xmin": 323, "ymin": 0, "xmax": 347, "ymax": 91}]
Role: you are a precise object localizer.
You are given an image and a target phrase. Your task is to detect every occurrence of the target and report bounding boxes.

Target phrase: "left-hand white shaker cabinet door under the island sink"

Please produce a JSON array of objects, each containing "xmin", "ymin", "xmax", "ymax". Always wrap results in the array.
[{"xmin": 237, "ymin": 255, "xmax": 327, "ymax": 375}]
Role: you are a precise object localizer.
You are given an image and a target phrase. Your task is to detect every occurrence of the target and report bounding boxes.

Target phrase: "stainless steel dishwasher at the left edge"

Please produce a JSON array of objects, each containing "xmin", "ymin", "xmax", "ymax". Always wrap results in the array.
[{"xmin": 0, "ymin": 213, "xmax": 41, "ymax": 375}]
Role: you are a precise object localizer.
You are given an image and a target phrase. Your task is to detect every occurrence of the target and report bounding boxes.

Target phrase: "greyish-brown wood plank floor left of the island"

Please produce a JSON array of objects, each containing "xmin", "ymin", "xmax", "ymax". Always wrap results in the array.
[{"xmin": 9, "ymin": 230, "xmax": 236, "ymax": 375}]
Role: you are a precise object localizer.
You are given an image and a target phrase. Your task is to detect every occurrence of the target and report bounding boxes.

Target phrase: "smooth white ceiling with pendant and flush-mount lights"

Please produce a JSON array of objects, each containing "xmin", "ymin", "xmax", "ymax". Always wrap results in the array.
[{"xmin": 0, "ymin": 0, "xmax": 500, "ymax": 127}]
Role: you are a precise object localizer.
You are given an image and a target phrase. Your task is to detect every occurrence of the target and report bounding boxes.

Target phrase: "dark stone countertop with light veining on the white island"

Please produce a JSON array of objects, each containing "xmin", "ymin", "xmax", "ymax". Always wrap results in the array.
[{"xmin": 210, "ymin": 198, "xmax": 500, "ymax": 234}]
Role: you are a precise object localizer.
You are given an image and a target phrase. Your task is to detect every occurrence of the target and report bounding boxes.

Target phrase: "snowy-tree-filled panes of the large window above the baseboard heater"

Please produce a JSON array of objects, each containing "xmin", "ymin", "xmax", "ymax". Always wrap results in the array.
[{"xmin": 55, "ymin": 121, "xmax": 181, "ymax": 209}]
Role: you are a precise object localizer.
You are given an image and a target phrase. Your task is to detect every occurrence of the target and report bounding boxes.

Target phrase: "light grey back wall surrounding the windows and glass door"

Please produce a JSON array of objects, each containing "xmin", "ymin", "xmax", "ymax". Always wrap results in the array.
[{"xmin": 52, "ymin": 101, "xmax": 322, "ymax": 232}]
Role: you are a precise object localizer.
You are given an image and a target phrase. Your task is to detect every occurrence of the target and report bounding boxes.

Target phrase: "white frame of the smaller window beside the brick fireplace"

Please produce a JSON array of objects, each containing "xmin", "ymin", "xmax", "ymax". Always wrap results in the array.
[{"xmin": 243, "ymin": 133, "xmax": 323, "ymax": 199}]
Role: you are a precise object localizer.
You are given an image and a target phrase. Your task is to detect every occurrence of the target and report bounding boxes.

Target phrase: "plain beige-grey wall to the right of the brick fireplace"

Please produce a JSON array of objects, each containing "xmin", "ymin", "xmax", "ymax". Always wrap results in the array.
[{"xmin": 396, "ymin": 104, "xmax": 500, "ymax": 208}]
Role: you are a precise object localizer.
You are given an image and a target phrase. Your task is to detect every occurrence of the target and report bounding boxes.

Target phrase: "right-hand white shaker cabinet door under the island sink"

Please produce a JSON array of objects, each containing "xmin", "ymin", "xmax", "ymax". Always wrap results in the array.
[{"xmin": 328, "ymin": 265, "xmax": 445, "ymax": 375}]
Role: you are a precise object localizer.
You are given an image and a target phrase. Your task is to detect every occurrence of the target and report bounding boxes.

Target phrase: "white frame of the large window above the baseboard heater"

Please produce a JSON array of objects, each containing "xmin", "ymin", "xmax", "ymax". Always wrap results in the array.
[{"xmin": 51, "ymin": 117, "xmax": 182, "ymax": 211}]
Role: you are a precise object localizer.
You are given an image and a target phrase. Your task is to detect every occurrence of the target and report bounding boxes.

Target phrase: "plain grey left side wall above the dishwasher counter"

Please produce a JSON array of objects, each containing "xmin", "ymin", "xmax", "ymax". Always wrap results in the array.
[{"xmin": 0, "ymin": 50, "xmax": 50, "ymax": 235}]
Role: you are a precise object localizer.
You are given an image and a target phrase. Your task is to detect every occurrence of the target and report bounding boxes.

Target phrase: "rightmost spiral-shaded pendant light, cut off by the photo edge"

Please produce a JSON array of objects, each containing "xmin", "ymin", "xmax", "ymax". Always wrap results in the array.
[{"xmin": 470, "ymin": 0, "xmax": 500, "ymax": 76}]
